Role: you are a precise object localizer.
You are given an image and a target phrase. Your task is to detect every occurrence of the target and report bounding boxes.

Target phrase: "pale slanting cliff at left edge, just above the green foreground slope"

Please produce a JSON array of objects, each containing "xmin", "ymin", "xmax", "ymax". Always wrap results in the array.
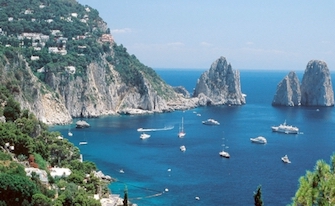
[{"xmin": 0, "ymin": 55, "xmax": 72, "ymax": 124}]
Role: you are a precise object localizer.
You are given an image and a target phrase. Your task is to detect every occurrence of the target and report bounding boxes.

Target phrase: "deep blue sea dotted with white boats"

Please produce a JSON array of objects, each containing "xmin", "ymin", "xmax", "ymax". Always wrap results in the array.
[{"xmin": 51, "ymin": 69, "xmax": 335, "ymax": 206}]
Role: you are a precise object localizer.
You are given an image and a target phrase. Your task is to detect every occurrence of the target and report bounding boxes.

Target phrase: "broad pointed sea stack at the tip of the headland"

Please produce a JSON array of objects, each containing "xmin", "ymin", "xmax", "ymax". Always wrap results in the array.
[{"xmin": 193, "ymin": 57, "xmax": 246, "ymax": 106}]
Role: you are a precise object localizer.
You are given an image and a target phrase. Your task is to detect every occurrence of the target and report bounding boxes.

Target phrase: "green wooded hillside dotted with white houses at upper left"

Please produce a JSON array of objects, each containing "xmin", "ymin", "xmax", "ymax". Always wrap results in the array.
[{"xmin": 0, "ymin": 0, "xmax": 110, "ymax": 83}]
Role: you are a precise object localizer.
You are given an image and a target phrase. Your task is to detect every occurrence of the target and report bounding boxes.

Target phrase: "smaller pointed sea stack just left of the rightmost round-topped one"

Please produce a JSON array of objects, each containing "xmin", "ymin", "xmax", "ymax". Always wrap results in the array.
[{"xmin": 272, "ymin": 71, "xmax": 301, "ymax": 106}]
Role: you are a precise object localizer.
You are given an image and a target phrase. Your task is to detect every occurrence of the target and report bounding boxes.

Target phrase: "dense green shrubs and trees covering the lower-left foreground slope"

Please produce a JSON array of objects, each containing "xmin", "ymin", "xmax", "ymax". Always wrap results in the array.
[{"xmin": 0, "ymin": 87, "xmax": 109, "ymax": 206}]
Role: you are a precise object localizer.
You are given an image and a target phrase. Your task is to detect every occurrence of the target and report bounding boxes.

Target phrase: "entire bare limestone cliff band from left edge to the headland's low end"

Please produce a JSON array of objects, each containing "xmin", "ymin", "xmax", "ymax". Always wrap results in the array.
[{"xmin": 0, "ymin": 51, "xmax": 198, "ymax": 125}]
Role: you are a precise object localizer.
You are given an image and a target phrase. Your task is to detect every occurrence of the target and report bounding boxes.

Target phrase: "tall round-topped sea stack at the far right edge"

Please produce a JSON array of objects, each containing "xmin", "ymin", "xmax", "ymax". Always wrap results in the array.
[{"xmin": 301, "ymin": 60, "xmax": 334, "ymax": 106}]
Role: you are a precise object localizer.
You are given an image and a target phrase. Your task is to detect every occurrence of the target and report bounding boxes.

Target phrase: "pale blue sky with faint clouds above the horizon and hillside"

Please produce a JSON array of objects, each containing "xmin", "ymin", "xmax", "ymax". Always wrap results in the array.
[{"xmin": 77, "ymin": 0, "xmax": 335, "ymax": 71}]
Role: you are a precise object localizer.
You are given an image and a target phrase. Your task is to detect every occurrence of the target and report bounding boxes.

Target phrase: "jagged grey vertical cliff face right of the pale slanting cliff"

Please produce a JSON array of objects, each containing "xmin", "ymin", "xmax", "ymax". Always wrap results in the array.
[{"xmin": 43, "ymin": 54, "xmax": 196, "ymax": 117}]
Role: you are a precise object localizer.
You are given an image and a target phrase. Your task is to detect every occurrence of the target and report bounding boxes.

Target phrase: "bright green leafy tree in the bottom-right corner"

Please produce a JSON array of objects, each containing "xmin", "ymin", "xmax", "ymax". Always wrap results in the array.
[{"xmin": 291, "ymin": 155, "xmax": 335, "ymax": 205}]
